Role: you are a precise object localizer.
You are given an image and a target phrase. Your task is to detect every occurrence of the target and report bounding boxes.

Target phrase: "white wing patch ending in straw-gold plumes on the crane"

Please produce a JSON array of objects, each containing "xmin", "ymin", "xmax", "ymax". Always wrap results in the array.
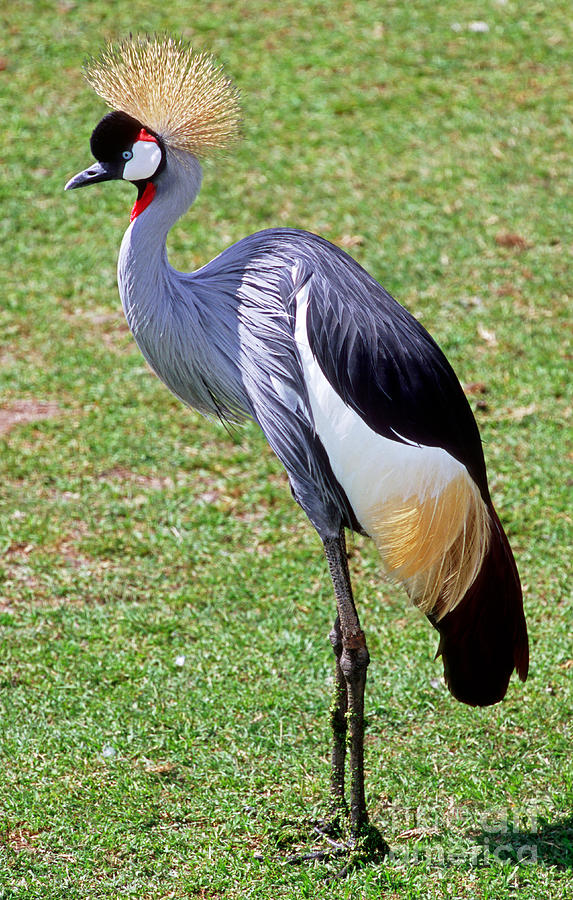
[{"xmin": 295, "ymin": 274, "xmax": 489, "ymax": 618}]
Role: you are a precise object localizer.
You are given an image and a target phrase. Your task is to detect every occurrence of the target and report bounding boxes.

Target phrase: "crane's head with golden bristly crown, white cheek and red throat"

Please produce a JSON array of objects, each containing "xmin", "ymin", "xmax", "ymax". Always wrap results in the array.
[{"xmin": 66, "ymin": 37, "xmax": 240, "ymax": 221}]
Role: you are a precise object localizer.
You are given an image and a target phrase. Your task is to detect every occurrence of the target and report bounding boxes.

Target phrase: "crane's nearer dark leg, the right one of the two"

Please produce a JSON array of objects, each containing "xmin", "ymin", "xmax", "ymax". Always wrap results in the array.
[{"xmin": 324, "ymin": 528, "xmax": 370, "ymax": 838}]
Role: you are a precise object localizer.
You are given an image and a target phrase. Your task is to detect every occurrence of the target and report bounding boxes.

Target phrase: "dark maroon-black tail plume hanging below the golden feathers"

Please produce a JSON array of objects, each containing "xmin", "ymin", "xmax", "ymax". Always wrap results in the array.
[{"xmin": 428, "ymin": 507, "xmax": 529, "ymax": 706}]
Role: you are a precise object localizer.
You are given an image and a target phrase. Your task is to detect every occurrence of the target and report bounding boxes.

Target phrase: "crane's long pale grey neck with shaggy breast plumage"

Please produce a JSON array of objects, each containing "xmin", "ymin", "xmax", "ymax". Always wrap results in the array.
[{"xmin": 118, "ymin": 153, "xmax": 251, "ymax": 420}]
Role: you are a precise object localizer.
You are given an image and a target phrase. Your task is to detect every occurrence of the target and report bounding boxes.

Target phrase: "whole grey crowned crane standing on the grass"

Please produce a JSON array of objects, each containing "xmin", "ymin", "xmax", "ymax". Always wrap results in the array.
[{"xmin": 66, "ymin": 37, "xmax": 528, "ymax": 852}]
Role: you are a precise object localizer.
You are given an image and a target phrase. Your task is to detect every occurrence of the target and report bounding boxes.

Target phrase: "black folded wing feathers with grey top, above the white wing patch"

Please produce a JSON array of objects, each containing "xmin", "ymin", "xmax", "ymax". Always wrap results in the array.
[{"xmin": 298, "ymin": 236, "xmax": 489, "ymax": 500}]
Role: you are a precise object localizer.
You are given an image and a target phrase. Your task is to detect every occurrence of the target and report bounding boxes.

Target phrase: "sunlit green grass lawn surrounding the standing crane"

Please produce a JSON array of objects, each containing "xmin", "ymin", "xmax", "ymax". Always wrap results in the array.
[{"xmin": 0, "ymin": 0, "xmax": 573, "ymax": 900}]
